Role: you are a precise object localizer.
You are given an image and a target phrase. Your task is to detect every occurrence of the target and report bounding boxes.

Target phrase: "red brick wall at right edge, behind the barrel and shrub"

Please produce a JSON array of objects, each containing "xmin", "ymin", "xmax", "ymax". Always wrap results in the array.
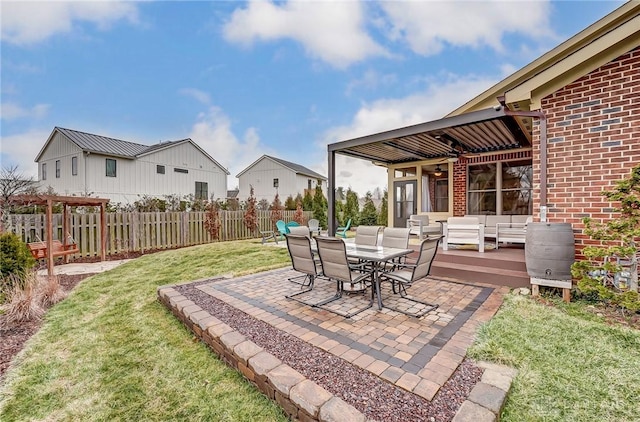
[{"xmin": 533, "ymin": 48, "xmax": 640, "ymax": 255}]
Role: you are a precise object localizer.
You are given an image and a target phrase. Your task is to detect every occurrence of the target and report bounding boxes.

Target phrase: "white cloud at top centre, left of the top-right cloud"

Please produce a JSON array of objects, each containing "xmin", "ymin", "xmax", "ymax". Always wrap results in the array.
[{"xmin": 224, "ymin": 0, "xmax": 389, "ymax": 68}]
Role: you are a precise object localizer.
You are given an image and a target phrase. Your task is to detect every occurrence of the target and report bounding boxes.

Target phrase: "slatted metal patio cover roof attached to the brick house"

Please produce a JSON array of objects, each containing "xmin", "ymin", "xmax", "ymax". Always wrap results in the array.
[{"xmin": 328, "ymin": 107, "xmax": 531, "ymax": 165}]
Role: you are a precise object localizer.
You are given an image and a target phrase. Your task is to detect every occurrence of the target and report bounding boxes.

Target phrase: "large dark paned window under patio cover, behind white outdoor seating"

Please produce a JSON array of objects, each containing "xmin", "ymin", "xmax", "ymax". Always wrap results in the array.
[{"xmin": 467, "ymin": 160, "xmax": 533, "ymax": 215}]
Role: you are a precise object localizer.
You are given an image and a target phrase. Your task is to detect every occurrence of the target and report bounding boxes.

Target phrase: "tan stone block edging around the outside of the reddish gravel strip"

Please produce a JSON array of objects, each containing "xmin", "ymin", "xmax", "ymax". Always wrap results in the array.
[{"xmin": 158, "ymin": 286, "xmax": 515, "ymax": 422}]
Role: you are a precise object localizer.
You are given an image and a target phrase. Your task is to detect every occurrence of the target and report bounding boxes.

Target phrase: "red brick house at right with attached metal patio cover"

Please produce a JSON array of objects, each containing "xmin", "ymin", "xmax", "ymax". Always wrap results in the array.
[{"xmin": 329, "ymin": 1, "xmax": 640, "ymax": 254}]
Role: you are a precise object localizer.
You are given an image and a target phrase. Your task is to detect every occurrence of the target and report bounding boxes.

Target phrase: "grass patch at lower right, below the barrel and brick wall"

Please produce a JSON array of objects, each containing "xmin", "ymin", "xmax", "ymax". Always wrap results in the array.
[{"xmin": 469, "ymin": 296, "xmax": 640, "ymax": 422}]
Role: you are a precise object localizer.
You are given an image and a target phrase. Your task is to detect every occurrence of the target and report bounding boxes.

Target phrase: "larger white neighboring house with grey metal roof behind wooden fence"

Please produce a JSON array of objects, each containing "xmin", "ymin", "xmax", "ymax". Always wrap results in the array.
[{"xmin": 35, "ymin": 127, "xmax": 229, "ymax": 203}]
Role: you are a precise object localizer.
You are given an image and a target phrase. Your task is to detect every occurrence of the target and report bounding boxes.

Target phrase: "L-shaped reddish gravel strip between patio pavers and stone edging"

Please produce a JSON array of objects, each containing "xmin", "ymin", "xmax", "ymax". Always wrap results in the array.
[{"xmin": 176, "ymin": 280, "xmax": 482, "ymax": 422}]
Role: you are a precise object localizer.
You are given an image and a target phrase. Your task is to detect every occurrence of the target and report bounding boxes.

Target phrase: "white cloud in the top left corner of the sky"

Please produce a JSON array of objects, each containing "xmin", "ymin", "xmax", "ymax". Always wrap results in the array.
[{"xmin": 1, "ymin": 1, "xmax": 138, "ymax": 45}]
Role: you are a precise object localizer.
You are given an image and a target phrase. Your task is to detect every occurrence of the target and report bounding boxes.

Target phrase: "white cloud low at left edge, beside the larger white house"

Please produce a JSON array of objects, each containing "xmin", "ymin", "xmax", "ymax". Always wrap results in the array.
[{"xmin": 0, "ymin": 129, "xmax": 51, "ymax": 176}]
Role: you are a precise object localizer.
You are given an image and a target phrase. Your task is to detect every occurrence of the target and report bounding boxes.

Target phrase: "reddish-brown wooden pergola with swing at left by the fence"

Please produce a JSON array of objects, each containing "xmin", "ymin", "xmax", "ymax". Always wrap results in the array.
[{"xmin": 8, "ymin": 195, "xmax": 109, "ymax": 276}]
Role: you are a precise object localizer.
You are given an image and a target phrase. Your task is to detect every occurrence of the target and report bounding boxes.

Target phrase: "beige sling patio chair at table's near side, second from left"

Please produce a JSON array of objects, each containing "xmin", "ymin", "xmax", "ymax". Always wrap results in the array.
[{"xmin": 315, "ymin": 236, "xmax": 373, "ymax": 318}]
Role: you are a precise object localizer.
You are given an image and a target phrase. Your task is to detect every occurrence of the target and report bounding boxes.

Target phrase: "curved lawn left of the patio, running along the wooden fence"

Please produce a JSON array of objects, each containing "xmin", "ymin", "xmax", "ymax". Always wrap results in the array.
[{"xmin": 0, "ymin": 241, "xmax": 290, "ymax": 421}]
